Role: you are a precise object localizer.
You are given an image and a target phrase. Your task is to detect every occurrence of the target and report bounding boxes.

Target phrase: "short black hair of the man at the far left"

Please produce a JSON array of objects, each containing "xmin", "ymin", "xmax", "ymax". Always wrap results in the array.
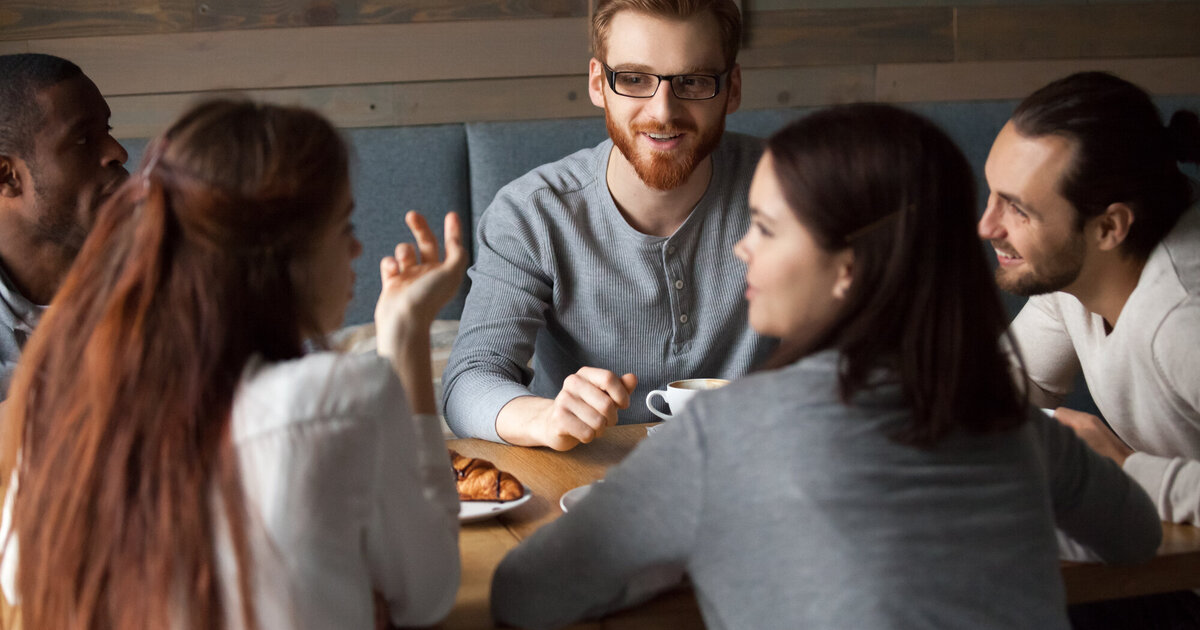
[{"xmin": 0, "ymin": 53, "xmax": 83, "ymax": 157}]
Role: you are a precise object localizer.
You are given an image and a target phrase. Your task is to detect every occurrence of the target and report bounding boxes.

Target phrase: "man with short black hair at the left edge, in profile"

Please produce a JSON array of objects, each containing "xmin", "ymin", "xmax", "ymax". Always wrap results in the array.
[{"xmin": 0, "ymin": 54, "xmax": 128, "ymax": 398}]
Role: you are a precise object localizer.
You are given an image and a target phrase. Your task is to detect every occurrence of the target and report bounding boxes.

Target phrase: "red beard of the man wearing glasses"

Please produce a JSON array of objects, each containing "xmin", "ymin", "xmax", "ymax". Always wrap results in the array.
[{"xmin": 604, "ymin": 99, "xmax": 725, "ymax": 191}]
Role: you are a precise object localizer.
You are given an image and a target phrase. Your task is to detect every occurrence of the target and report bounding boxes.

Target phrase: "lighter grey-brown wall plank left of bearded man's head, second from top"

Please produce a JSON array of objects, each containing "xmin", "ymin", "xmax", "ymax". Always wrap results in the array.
[{"xmin": 22, "ymin": 18, "xmax": 589, "ymax": 95}]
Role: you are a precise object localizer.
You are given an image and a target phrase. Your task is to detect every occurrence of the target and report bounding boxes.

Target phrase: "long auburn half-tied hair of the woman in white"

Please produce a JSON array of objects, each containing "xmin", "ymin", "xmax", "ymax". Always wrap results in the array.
[{"xmin": 0, "ymin": 101, "xmax": 348, "ymax": 630}]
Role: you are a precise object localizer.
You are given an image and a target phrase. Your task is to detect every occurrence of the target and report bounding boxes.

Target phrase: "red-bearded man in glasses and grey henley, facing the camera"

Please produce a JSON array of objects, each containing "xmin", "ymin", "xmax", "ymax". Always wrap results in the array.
[{"xmin": 443, "ymin": 0, "xmax": 769, "ymax": 450}]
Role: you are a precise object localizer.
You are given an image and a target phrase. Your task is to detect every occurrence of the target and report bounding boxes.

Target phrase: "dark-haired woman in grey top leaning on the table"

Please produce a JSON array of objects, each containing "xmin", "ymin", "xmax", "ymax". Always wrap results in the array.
[{"xmin": 492, "ymin": 104, "xmax": 1160, "ymax": 629}]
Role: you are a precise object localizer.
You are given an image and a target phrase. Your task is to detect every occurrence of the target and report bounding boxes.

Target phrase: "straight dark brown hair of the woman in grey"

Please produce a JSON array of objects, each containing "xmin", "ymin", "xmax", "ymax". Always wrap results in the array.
[{"xmin": 767, "ymin": 103, "xmax": 1025, "ymax": 446}]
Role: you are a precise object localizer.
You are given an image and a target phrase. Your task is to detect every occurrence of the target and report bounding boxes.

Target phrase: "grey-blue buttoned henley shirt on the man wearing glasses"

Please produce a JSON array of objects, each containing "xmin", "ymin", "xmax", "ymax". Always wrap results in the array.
[{"xmin": 442, "ymin": 133, "xmax": 770, "ymax": 442}]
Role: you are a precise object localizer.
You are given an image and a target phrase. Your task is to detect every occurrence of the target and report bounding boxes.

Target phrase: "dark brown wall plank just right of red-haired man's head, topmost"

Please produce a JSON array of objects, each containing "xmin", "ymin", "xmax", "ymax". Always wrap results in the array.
[{"xmin": 739, "ymin": 7, "xmax": 954, "ymax": 67}]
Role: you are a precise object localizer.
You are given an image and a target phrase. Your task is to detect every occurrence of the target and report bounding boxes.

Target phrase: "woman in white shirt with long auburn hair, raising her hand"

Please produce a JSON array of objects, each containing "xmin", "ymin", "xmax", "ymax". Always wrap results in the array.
[{"xmin": 0, "ymin": 101, "xmax": 466, "ymax": 630}]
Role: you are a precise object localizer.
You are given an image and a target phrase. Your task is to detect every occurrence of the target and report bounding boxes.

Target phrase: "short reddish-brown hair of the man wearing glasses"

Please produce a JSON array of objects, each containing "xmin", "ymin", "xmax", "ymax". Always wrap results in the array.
[{"xmin": 589, "ymin": 0, "xmax": 742, "ymax": 72}]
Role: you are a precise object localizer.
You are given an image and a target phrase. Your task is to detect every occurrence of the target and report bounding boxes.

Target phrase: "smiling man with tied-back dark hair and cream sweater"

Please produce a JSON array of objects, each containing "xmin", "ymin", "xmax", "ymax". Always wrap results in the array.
[{"xmin": 979, "ymin": 72, "xmax": 1200, "ymax": 629}]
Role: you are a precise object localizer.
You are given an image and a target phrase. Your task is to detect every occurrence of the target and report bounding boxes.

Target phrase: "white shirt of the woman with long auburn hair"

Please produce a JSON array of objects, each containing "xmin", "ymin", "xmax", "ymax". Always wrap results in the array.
[{"xmin": 0, "ymin": 353, "xmax": 460, "ymax": 630}]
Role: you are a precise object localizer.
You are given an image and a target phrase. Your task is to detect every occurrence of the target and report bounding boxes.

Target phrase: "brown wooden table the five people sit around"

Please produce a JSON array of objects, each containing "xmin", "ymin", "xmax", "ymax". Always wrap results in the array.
[{"xmin": 440, "ymin": 425, "xmax": 1200, "ymax": 630}]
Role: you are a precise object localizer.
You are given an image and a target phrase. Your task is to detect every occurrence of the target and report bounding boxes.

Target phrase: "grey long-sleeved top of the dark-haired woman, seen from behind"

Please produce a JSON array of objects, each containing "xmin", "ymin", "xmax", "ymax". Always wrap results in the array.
[{"xmin": 492, "ymin": 352, "xmax": 1162, "ymax": 630}]
